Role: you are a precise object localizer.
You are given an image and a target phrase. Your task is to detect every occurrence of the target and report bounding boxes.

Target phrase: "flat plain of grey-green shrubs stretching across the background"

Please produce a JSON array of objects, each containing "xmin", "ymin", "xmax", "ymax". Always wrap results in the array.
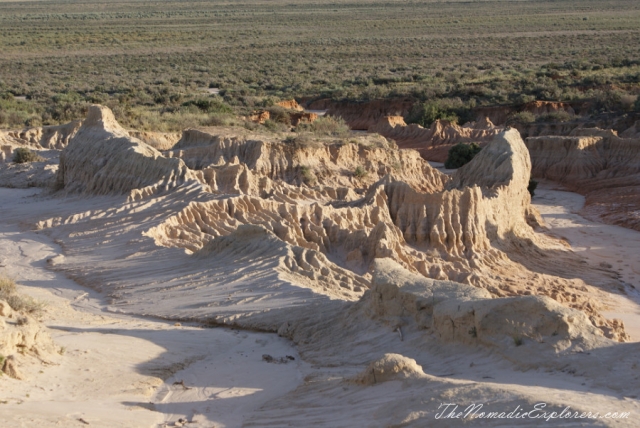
[{"xmin": 0, "ymin": 0, "xmax": 640, "ymax": 131}]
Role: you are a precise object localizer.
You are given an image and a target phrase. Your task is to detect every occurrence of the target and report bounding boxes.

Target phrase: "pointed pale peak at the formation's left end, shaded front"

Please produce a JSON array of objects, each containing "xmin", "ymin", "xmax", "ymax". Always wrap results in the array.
[{"xmin": 57, "ymin": 105, "xmax": 192, "ymax": 195}]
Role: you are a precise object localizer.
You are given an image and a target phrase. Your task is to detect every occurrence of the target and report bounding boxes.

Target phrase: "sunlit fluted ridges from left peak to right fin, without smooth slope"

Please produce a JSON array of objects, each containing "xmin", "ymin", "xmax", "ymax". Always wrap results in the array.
[{"xmin": 7, "ymin": 106, "xmax": 626, "ymax": 340}]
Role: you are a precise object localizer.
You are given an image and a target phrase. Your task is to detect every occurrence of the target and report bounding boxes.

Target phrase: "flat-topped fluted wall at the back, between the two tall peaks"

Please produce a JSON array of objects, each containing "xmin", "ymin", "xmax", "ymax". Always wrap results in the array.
[{"xmin": 167, "ymin": 129, "xmax": 447, "ymax": 190}]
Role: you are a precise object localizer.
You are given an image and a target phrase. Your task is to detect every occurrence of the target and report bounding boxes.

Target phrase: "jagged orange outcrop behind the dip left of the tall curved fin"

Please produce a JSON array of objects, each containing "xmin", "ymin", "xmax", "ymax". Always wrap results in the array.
[{"xmin": 369, "ymin": 116, "xmax": 504, "ymax": 162}]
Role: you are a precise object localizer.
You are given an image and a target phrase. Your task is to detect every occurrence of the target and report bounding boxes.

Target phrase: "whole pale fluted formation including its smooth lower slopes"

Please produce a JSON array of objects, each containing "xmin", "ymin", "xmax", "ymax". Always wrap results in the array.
[{"xmin": 1, "ymin": 106, "xmax": 640, "ymax": 426}]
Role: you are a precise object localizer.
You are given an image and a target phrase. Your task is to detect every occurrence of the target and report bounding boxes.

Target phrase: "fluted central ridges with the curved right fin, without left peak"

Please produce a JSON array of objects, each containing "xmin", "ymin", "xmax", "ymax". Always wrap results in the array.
[{"xmin": 141, "ymin": 125, "xmax": 625, "ymax": 339}]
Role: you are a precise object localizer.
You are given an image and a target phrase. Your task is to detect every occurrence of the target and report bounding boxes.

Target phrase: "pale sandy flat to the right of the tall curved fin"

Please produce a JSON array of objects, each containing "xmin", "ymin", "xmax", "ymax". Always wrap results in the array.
[{"xmin": 533, "ymin": 182, "xmax": 640, "ymax": 342}]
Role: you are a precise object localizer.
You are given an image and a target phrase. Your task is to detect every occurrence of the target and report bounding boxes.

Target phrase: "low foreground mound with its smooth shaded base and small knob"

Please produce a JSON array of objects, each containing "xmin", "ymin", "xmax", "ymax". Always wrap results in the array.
[{"xmin": 278, "ymin": 259, "xmax": 640, "ymax": 408}]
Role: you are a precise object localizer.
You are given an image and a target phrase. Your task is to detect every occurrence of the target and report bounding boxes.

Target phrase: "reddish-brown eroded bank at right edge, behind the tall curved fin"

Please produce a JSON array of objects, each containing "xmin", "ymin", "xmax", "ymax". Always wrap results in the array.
[{"xmin": 526, "ymin": 128, "xmax": 640, "ymax": 230}]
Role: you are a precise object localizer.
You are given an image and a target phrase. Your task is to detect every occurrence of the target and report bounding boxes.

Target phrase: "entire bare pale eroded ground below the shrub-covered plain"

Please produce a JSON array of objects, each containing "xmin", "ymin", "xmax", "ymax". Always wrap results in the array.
[{"xmin": 0, "ymin": 105, "xmax": 640, "ymax": 427}]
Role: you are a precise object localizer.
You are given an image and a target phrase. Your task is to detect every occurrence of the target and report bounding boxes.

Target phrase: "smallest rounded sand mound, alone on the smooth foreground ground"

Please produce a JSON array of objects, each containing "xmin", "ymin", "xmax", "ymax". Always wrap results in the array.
[{"xmin": 353, "ymin": 354, "xmax": 425, "ymax": 385}]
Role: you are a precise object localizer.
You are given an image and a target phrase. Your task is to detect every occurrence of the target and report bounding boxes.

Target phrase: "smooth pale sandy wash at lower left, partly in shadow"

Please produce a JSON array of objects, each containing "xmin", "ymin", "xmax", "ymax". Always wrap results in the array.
[{"xmin": 0, "ymin": 189, "xmax": 306, "ymax": 428}]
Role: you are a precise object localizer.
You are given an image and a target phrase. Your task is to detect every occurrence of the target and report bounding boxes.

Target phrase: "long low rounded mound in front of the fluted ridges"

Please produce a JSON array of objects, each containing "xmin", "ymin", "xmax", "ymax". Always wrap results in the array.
[{"xmin": 364, "ymin": 259, "xmax": 608, "ymax": 356}]
